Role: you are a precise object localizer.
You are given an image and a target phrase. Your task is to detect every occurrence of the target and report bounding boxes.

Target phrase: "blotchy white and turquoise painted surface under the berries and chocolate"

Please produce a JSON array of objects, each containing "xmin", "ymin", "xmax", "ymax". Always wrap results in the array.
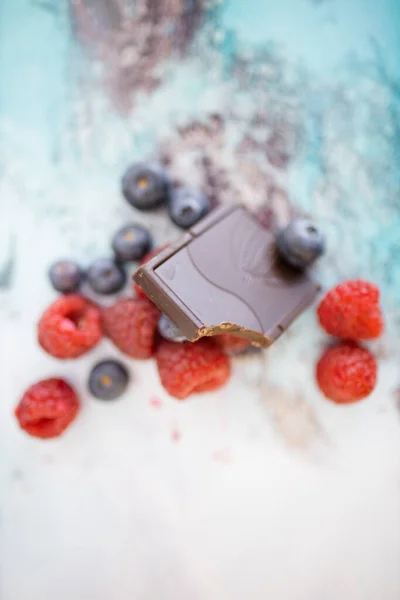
[{"xmin": 0, "ymin": 0, "xmax": 400, "ymax": 600}]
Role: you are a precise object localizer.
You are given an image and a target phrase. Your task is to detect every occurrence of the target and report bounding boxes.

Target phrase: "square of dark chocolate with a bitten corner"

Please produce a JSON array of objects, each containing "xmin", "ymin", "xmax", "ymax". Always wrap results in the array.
[{"xmin": 133, "ymin": 205, "xmax": 319, "ymax": 347}]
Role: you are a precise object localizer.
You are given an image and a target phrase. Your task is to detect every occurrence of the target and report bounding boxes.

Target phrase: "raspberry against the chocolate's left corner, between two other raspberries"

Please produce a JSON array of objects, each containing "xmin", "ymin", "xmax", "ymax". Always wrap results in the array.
[{"xmin": 103, "ymin": 298, "xmax": 160, "ymax": 359}]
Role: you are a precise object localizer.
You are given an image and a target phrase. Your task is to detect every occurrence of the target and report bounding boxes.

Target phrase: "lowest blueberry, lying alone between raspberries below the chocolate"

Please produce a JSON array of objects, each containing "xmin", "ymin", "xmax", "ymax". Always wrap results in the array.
[{"xmin": 88, "ymin": 360, "xmax": 129, "ymax": 400}]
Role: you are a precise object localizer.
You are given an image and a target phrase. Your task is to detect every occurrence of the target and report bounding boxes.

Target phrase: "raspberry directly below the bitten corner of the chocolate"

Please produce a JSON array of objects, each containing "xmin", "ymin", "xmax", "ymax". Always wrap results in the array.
[{"xmin": 156, "ymin": 339, "xmax": 231, "ymax": 400}]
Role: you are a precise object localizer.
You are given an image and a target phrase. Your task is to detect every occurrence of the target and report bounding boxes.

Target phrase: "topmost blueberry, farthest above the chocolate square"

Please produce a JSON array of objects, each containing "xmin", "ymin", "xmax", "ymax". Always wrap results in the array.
[{"xmin": 122, "ymin": 163, "xmax": 168, "ymax": 210}]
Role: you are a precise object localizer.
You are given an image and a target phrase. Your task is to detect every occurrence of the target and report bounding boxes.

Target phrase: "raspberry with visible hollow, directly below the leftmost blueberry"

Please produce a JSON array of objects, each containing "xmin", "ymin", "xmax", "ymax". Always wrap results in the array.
[{"xmin": 38, "ymin": 294, "xmax": 102, "ymax": 358}]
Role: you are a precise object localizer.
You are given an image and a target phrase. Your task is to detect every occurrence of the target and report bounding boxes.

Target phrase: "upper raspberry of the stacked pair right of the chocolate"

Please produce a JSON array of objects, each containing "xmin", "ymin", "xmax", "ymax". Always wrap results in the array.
[{"xmin": 318, "ymin": 280, "xmax": 383, "ymax": 340}]
